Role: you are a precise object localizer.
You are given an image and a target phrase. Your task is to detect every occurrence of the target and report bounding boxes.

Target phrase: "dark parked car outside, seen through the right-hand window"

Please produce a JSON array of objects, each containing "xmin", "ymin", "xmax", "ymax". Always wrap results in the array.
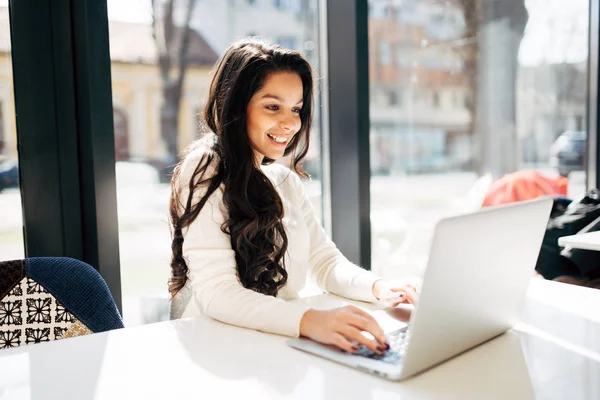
[{"xmin": 550, "ymin": 131, "xmax": 587, "ymax": 176}]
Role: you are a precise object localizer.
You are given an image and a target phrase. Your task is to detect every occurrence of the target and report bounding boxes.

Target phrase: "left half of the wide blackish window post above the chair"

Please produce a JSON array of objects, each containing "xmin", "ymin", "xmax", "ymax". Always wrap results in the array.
[{"xmin": 9, "ymin": 0, "xmax": 68, "ymax": 257}]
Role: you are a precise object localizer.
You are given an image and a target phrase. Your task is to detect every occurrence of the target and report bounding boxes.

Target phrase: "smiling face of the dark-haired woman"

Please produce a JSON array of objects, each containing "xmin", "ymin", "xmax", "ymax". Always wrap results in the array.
[{"xmin": 246, "ymin": 72, "xmax": 303, "ymax": 165}]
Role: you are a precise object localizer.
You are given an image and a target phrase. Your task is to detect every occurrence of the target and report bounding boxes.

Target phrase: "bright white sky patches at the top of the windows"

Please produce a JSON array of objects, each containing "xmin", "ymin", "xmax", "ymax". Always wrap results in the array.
[{"xmin": 0, "ymin": 0, "xmax": 589, "ymax": 65}]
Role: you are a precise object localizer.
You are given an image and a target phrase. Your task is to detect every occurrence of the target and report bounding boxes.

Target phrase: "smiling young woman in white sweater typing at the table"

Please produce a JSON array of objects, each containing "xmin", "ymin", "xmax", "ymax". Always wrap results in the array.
[{"xmin": 169, "ymin": 39, "xmax": 416, "ymax": 353}]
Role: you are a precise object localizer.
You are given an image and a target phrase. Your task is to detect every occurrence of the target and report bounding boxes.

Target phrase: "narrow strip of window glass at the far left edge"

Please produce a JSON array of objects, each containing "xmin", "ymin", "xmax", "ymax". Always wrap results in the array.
[{"xmin": 0, "ymin": 1, "xmax": 25, "ymax": 261}]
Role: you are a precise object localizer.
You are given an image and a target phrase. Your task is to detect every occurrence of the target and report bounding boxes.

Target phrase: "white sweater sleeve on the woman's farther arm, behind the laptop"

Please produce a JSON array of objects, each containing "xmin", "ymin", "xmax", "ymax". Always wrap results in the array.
[{"xmin": 289, "ymin": 172, "xmax": 381, "ymax": 302}]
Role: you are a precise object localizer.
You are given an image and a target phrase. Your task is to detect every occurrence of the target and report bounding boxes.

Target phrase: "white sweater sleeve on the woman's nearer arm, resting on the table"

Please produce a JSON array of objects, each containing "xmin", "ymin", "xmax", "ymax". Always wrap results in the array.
[{"xmin": 181, "ymin": 152, "xmax": 310, "ymax": 337}]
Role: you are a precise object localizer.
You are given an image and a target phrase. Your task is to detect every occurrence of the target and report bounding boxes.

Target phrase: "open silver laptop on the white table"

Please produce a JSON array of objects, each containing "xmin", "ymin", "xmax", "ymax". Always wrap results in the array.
[{"xmin": 287, "ymin": 197, "xmax": 552, "ymax": 380}]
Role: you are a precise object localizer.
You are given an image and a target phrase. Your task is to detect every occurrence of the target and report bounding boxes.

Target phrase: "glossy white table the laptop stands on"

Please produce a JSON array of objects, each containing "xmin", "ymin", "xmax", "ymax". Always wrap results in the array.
[{"xmin": 0, "ymin": 279, "xmax": 600, "ymax": 400}]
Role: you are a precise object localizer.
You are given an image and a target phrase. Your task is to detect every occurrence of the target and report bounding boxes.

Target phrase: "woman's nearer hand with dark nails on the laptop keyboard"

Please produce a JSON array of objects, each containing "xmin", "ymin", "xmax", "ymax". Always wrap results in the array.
[{"xmin": 300, "ymin": 306, "xmax": 390, "ymax": 354}]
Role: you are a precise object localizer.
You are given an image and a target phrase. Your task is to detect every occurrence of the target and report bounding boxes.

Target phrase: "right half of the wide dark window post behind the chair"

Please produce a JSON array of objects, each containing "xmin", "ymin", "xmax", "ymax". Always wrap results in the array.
[{"xmin": 71, "ymin": 0, "xmax": 121, "ymax": 308}]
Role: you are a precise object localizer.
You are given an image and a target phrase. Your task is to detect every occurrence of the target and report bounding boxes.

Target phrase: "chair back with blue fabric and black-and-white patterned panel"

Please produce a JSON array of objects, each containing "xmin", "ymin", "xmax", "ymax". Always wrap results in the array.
[{"xmin": 0, "ymin": 257, "xmax": 123, "ymax": 349}]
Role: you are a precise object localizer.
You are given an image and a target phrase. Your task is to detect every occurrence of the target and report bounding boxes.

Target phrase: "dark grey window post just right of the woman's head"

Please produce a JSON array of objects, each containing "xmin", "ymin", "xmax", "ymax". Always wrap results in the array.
[{"xmin": 326, "ymin": 0, "xmax": 371, "ymax": 269}]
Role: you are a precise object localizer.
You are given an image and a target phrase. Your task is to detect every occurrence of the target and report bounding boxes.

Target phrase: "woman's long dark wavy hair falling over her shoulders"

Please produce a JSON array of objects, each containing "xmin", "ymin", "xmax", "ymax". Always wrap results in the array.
[{"xmin": 169, "ymin": 39, "xmax": 313, "ymax": 296}]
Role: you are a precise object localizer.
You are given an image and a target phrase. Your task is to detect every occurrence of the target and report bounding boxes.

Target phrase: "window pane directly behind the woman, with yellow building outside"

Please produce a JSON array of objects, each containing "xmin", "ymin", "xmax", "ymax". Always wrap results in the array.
[{"xmin": 108, "ymin": 0, "xmax": 321, "ymax": 326}]
